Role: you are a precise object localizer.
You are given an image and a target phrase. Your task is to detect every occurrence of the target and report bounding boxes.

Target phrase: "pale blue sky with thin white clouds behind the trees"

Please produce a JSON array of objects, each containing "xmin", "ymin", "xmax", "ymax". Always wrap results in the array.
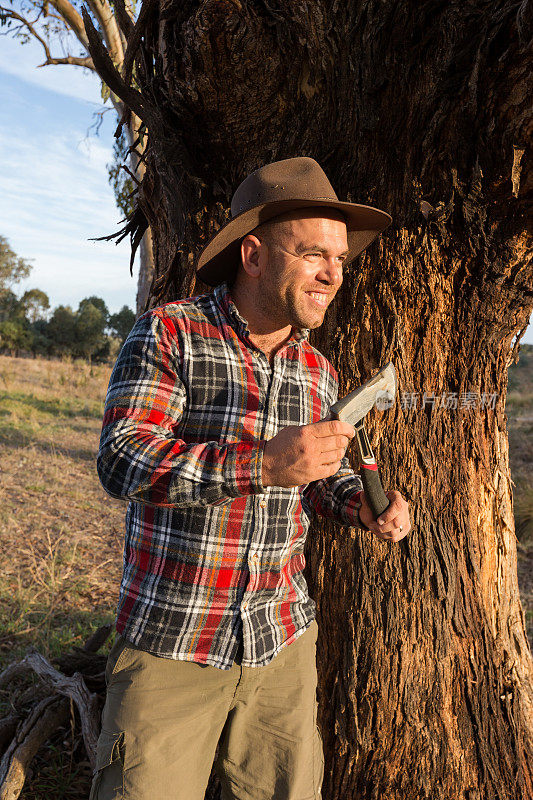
[{"xmin": 0, "ymin": 36, "xmax": 533, "ymax": 344}]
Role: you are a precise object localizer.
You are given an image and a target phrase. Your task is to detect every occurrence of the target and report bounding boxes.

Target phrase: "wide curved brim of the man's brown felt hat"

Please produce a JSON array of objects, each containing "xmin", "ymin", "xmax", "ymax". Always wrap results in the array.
[{"xmin": 196, "ymin": 198, "xmax": 392, "ymax": 286}]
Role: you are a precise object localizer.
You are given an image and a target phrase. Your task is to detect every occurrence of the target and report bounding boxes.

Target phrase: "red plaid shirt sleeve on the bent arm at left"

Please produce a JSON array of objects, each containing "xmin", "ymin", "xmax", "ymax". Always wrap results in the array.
[{"xmin": 97, "ymin": 312, "xmax": 265, "ymax": 507}]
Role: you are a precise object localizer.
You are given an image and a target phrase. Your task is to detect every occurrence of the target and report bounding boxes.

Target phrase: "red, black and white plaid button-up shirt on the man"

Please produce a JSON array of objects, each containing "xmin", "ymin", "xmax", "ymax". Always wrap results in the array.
[{"xmin": 97, "ymin": 283, "xmax": 362, "ymax": 669}]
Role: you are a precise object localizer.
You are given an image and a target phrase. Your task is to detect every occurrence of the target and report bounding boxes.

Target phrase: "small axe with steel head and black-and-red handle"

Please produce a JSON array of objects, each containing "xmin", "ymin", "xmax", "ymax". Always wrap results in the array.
[{"xmin": 329, "ymin": 361, "xmax": 396, "ymax": 519}]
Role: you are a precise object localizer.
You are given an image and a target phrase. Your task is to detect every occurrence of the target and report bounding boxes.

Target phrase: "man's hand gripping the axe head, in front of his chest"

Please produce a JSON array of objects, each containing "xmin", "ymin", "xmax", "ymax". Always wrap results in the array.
[{"xmin": 261, "ymin": 419, "xmax": 355, "ymax": 489}]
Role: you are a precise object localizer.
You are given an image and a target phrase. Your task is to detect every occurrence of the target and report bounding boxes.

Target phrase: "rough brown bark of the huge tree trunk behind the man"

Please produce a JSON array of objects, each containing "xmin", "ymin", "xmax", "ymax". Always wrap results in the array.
[{"xmin": 86, "ymin": 0, "xmax": 533, "ymax": 800}]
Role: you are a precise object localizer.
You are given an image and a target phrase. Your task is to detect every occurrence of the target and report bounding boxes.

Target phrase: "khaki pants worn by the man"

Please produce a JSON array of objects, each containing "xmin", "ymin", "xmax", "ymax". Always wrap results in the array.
[{"xmin": 90, "ymin": 620, "xmax": 324, "ymax": 800}]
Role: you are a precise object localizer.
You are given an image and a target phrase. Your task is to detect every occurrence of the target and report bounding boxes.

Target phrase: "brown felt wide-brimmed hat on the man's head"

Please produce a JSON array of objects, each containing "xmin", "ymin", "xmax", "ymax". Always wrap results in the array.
[{"xmin": 196, "ymin": 157, "xmax": 392, "ymax": 286}]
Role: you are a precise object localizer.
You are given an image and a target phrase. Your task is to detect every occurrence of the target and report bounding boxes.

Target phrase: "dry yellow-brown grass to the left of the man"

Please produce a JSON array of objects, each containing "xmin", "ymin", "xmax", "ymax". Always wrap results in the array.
[{"xmin": 0, "ymin": 356, "xmax": 125, "ymax": 666}]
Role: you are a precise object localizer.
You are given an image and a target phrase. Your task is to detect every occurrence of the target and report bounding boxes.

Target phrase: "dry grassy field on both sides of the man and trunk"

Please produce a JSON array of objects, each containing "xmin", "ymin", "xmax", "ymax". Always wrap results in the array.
[{"xmin": 0, "ymin": 345, "xmax": 533, "ymax": 800}]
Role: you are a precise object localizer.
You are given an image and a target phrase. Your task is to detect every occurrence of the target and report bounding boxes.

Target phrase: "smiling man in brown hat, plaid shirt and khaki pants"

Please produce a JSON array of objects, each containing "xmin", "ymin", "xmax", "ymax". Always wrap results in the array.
[{"xmin": 91, "ymin": 158, "xmax": 410, "ymax": 800}]
